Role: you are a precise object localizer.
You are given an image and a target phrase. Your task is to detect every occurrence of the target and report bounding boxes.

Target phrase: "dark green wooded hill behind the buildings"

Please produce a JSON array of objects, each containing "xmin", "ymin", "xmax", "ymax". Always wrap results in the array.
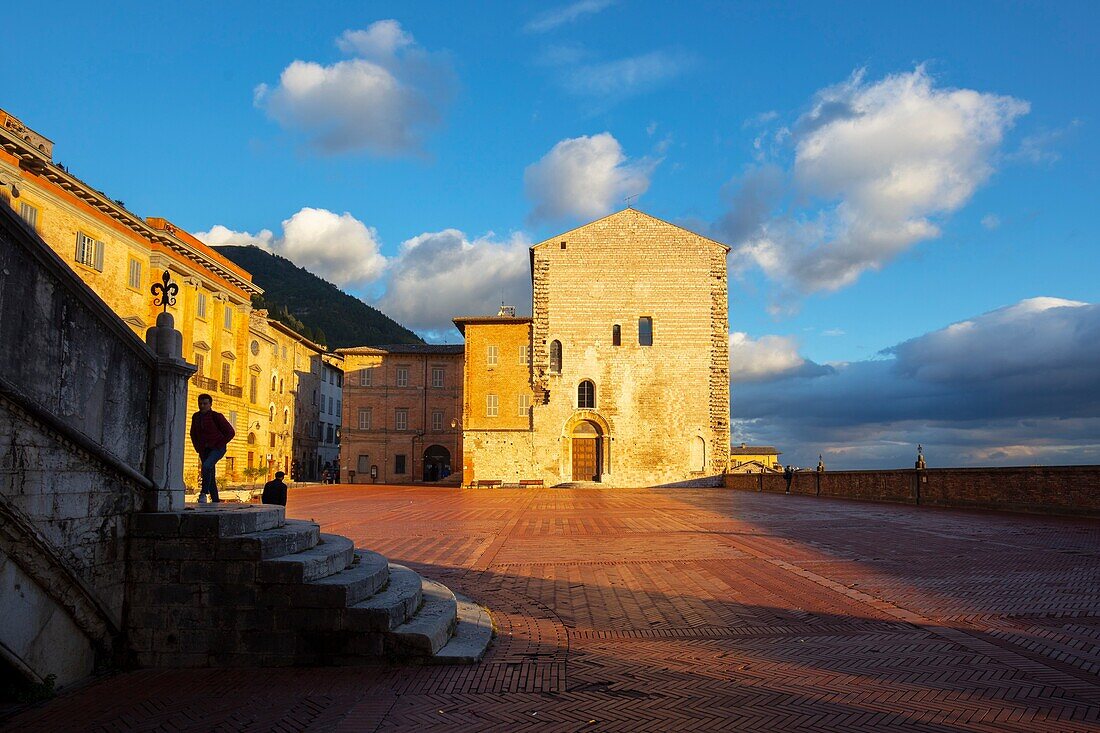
[{"xmin": 213, "ymin": 245, "xmax": 424, "ymax": 349}]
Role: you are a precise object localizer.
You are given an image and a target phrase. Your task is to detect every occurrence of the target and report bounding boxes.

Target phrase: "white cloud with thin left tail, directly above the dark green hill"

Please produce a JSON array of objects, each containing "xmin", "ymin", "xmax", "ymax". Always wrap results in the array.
[{"xmin": 195, "ymin": 207, "xmax": 386, "ymax": 287}]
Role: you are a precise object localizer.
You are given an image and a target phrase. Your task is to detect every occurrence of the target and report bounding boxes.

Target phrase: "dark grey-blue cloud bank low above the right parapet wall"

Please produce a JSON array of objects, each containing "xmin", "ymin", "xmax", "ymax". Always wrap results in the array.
[{"xmin": 732, "ymin": 297, "xmax": 1100, "ymax": 468}]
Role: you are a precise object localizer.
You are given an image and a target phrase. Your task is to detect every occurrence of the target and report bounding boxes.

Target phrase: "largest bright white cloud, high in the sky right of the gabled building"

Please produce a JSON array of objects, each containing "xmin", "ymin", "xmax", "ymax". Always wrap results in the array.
[{"xmin": 719, "ymin": 67, "xmax": 1029, "ymax": 292}]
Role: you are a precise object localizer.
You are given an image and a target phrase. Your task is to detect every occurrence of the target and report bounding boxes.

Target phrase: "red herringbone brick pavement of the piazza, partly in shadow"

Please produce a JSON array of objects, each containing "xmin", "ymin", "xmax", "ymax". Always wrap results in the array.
[{"xmin": 9, "ymin": 486, "xmax": 1100, "ymax": 732}]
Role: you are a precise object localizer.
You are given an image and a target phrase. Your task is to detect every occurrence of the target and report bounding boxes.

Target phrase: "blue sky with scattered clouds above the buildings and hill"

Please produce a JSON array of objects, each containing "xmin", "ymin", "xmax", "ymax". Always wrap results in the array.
[{"xmin": 0, "ymin": 0, "xmax": 1100, "ymax": 467}]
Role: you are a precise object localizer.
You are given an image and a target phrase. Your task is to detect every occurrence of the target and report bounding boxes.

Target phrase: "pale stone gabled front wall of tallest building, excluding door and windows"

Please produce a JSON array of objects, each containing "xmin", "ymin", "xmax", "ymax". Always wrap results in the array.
[{"xmin": 530, "ymin": 209, "xmax": 729, "ymax": 486}]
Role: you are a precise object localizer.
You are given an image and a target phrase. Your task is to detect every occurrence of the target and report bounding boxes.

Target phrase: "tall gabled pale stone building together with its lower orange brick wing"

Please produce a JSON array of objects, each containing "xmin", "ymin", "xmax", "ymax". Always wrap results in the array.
[{"xmin": 454, "ymin": 209, "xmax": 729, "ymax": 486}]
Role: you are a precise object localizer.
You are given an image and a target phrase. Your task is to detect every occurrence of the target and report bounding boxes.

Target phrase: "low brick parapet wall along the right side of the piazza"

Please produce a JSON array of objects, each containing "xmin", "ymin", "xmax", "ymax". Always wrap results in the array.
[{"xmin": 726, "ymin": 466, "xmax": 1100, "ymax": 516}]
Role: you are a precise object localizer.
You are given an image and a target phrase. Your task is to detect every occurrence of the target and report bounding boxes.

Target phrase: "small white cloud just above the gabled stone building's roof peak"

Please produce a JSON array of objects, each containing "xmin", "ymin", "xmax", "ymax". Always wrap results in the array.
[{"xmin": 524, "ymin": 132, "xmax": 657, "ymax": 221}]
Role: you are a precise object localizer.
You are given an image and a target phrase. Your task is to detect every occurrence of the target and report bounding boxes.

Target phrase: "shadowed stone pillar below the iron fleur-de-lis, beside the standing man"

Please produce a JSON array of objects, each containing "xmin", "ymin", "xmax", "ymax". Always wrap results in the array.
[{"xmin": 143, "ymin": 311, "xmax": 196, "ymax": 512}]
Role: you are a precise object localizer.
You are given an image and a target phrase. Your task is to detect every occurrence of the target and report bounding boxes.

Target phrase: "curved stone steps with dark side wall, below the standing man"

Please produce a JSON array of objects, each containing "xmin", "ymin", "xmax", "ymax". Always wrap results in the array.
[{"xmin": 125, "ymin": 504, "xmax": 493, "ymax": 667}]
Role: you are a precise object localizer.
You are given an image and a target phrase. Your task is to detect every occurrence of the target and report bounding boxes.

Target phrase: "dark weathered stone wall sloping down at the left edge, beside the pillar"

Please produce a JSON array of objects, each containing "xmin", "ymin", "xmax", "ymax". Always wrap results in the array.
[{"xmin": 0, "ymin": 206, "xmax": 154, "ymax": 683}]
